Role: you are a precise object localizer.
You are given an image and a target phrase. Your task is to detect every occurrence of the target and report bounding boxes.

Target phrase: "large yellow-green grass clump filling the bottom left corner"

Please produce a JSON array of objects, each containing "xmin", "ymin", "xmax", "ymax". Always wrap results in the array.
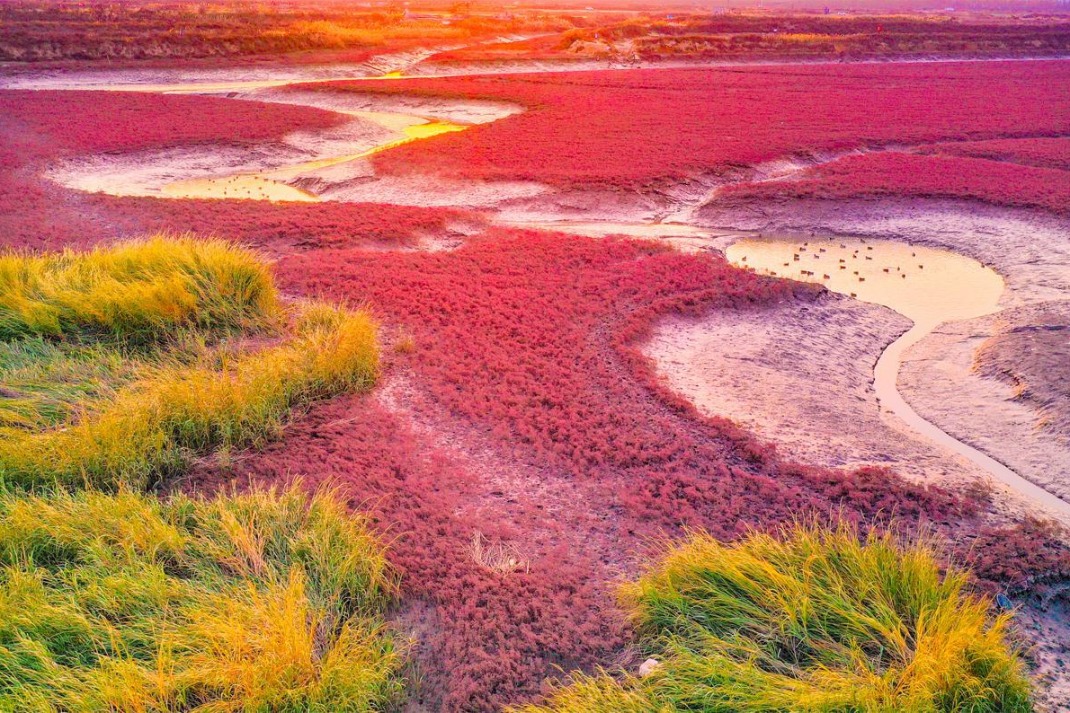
[{"xmin": 0, "ymin": 489, "xmax": 400, "ymax": 713}]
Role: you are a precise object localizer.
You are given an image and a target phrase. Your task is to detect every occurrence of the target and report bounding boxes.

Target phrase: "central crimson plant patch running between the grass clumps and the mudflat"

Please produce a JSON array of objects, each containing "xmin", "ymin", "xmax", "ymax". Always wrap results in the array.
[{"xmin": 193, "ymin": 230, "xmax": 1068, "ymax": 711}]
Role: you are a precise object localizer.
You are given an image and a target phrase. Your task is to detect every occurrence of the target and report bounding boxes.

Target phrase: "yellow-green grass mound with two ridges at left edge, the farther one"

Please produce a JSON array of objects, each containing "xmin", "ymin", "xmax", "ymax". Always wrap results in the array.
[{"xmin": 0, "ymin": 233, "xmax": 379, "ymax": 488}]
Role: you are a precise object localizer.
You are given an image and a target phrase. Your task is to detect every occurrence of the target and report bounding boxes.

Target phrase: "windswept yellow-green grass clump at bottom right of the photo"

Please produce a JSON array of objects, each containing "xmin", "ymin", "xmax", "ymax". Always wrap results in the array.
[{"xmin": 523, "ymin": 528, "xmax": 1031, "ymax": 713}]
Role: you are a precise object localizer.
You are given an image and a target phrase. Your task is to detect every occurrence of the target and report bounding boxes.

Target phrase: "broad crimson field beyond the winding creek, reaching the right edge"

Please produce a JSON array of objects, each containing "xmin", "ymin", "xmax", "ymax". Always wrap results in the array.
[{"xmin": 302, "ymin": 61, "xmax": 1070, "ymax": 188}]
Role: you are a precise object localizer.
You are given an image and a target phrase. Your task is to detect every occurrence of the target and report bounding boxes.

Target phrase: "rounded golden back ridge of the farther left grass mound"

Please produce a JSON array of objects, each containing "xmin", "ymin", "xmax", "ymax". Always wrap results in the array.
[{"xmin": 0, "ymin": 237, "xmax": 279, "ymax": 340}]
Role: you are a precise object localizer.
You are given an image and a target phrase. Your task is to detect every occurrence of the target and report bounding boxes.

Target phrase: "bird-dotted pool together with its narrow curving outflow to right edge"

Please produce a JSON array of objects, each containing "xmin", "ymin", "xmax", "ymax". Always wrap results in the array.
[{"xmin": 725, "ymin": 238, "xmax": 1070, "ymax": 516}]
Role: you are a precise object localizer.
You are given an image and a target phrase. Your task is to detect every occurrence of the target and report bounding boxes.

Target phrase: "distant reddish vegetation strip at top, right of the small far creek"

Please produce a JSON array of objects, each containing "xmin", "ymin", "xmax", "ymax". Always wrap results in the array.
[{"xmin": 427, "ymin": 14, "xmax": 1070, "ymax": 69}]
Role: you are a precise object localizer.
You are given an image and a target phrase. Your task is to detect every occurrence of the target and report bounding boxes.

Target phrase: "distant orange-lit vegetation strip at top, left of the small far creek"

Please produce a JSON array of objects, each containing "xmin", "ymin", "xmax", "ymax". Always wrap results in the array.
[{"xmin": 0, "ymin": 0, "xmax": 575, "ymax": 62}]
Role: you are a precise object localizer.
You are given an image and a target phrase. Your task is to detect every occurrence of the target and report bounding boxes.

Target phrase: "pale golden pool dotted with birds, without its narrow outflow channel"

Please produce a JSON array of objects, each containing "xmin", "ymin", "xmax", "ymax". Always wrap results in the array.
[{"xmin": 727, "ymin": 238, "xmax": 1004, "ymax": 327}]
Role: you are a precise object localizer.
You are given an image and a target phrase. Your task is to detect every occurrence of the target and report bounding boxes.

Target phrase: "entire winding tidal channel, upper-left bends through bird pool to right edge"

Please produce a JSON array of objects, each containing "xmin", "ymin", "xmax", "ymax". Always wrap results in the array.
[{"xmin": 14, "ymin": 66, "xmax": 1070, "ymax": 520}]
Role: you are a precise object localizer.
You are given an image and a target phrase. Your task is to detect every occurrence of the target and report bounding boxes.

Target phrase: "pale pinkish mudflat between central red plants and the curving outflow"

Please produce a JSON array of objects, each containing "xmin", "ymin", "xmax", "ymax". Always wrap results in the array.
[{"xmin": 644, "ymin": 293, "xmax": 992, "ymax": 483}]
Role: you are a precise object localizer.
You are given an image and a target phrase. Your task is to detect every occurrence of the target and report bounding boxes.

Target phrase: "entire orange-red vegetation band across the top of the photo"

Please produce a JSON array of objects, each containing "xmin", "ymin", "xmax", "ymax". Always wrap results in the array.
[{"xmin": 6, "ymin": 0, "xmax": 1070, "ymax": 64}]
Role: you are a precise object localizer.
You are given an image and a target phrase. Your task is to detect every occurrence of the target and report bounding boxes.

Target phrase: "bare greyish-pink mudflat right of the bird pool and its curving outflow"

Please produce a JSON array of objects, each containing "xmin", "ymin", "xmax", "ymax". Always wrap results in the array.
[{"xmin": 701, "ymin": 200, "xmax": 1070, "ymax": 505}]
